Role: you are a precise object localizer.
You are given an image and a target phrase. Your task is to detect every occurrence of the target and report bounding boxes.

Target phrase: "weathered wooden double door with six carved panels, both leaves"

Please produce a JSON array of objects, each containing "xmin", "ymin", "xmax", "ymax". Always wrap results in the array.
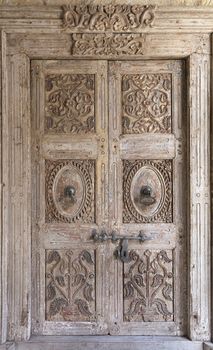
[{"xmin": 31, "ymin": 60, "xmax": 187, "ymax": 335}]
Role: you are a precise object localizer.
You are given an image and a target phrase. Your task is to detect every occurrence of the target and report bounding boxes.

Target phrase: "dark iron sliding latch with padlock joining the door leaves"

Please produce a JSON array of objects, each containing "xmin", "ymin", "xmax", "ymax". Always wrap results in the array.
[{"xmin": 91, "ymin": 230, "xmax": 154, "ymax": 262}]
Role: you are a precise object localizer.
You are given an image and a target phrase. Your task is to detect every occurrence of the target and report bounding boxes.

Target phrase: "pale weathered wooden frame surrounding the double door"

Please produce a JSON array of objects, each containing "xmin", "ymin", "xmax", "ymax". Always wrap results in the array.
[{"xmin": 0, "ymin": 6, "xmax": 213, "ymax": 343}]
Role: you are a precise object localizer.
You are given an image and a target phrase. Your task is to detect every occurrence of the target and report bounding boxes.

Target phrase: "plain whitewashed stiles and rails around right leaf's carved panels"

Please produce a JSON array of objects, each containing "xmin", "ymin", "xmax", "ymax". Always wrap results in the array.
[{"xmin": 109, "ymin": 60, "xmax": 187, "ymax": 335}]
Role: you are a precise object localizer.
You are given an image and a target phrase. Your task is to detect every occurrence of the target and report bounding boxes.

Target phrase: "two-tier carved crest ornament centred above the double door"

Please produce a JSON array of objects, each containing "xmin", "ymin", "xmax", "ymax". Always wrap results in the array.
[{"xmin": 62, "ymin": 4, "xmax": 155, "ymax": 57}]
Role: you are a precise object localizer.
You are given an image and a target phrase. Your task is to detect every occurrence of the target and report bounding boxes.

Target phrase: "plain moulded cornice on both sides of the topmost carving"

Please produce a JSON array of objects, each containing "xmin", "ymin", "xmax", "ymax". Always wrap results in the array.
[{"xmin": 0, "ymin": 6, "xmax": 213, "ymax": 33}]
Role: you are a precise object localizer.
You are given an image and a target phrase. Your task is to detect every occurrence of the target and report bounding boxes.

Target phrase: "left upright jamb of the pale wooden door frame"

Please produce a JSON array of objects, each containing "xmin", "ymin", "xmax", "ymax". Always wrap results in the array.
[{"xmin": 5, "ymin": 54, "xmax": 31, "ymax": 340}]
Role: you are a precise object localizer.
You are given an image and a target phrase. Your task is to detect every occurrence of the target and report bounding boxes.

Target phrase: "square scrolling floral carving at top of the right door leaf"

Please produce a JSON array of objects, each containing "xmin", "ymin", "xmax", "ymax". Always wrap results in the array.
[{"xmin": 122, "ymin": 73, "xmax": 172, "ymax": 134}]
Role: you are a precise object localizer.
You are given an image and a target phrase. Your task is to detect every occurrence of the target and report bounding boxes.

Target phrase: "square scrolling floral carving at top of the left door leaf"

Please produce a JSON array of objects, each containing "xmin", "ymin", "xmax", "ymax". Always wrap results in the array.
[{"xmin": 45, "ymin": 74, "xmax": 95, "ymax": 133}]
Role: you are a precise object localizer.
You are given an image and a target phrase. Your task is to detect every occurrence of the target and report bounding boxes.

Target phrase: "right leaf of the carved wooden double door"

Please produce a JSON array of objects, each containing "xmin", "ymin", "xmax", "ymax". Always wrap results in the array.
[{"xmin": 109, "ymin": 61, "xmax": 187, "ymax": 335}]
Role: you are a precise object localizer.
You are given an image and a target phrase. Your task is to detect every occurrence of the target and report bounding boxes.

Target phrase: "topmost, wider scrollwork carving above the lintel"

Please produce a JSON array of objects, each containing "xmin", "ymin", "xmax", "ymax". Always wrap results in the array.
[{"xmin": 63, "ymin": 5, "xmax": 155, "ymax": 32}]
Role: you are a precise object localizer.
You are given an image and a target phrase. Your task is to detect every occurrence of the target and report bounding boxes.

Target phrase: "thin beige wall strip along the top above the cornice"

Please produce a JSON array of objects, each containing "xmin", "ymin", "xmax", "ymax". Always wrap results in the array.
[{"xmin": 0, "ymin": 0, "xmax": 213, "ymax": 7}]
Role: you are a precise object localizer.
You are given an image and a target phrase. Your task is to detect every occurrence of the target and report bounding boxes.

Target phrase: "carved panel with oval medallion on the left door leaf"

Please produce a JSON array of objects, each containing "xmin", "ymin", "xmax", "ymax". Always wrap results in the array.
[{"xmin": 45, "ymin": 160, "xmax": 95, "ymax": 223}]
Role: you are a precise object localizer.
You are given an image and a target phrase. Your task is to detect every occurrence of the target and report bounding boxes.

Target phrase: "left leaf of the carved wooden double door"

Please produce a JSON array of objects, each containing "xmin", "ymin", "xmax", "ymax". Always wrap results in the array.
[{"xmin": 32, "ymin": 61, "xmax": 108, "ymax": 334}]
